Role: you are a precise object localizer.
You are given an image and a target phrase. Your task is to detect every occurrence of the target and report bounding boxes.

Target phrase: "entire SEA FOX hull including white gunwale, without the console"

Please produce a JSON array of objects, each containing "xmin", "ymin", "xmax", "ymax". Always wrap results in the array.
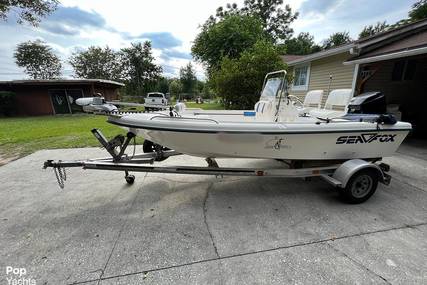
[{"xmin": 108, "ymin": 114, "xmax": 411, "ymax": 160}]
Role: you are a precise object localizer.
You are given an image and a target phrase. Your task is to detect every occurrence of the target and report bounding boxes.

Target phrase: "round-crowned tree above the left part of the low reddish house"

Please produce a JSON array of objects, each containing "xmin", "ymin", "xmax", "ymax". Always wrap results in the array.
[{"xmin": 13, "ymin": 40, "xmax": 62, "ymax": 79}]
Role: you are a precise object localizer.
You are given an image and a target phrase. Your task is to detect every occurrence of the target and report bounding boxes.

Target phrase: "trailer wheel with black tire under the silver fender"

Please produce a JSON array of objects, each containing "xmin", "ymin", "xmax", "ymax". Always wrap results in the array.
[{"xmin": 341, "ymin": 169, "xmax": 379, "ymax": 204}]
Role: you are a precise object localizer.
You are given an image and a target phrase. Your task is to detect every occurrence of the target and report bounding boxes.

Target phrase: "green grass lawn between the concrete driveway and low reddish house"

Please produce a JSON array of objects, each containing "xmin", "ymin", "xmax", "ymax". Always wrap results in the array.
[{"xmin": 0, "ymin": 102, "xmax": 226, "ymax": 158}]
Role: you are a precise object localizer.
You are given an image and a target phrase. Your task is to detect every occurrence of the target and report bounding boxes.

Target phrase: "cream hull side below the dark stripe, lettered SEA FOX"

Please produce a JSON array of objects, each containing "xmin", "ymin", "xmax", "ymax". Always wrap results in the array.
[{"xmin": 138, "ymin": 129, "xmax": 408, "ymax": 160}]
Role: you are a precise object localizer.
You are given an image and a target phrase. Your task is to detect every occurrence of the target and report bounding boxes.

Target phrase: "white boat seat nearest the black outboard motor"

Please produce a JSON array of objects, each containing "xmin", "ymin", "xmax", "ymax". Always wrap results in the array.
[{"xmin": 309, "ymin": 89, "xmax": 353, "ymax": 119}]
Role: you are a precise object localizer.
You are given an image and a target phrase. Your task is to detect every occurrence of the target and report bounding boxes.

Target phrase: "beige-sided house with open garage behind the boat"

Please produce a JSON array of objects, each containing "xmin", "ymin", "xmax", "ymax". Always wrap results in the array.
[{"xmin": 283, "ymin": 20, "xmax": 427, "ymax": 136}]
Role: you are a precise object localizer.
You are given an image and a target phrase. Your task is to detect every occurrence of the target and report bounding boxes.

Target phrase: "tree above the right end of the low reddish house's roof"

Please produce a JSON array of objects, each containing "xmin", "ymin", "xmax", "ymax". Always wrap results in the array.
[{"xmin": 69, "ymin": 46, "xmax": 122, "ymax": 80}]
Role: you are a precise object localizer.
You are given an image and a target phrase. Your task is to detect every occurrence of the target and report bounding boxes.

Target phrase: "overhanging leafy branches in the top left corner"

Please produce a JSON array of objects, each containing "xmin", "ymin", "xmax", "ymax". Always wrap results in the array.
[{"xmin": 0, "ymin": 0, "xmax": 59, "ymax": 26}]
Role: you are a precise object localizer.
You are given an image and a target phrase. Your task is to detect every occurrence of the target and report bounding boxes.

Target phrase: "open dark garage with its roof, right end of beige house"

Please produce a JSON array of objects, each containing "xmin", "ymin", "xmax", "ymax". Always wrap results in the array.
[{"xmin": 344, "ymin": 28, "xmax": 427, "ymax": 138}]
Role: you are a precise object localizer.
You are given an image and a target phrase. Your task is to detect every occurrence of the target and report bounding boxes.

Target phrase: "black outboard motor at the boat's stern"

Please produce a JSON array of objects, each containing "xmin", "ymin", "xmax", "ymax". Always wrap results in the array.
[{"xmin": 348, "ymin": 92, "xmax": 387, "ymax": 114}]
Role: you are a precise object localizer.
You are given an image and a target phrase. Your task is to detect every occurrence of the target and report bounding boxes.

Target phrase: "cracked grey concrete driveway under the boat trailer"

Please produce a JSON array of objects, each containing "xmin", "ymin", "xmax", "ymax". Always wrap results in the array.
[{"xmin": 0, "ymin": 143, "xmax": 427, "ymax": 284}]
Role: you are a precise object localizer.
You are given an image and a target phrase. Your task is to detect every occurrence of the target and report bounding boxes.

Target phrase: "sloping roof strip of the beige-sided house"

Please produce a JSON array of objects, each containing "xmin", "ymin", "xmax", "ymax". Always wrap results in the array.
[{"xmin": 287, "ymin": 19, "xmax": 427, "ymax": 66}]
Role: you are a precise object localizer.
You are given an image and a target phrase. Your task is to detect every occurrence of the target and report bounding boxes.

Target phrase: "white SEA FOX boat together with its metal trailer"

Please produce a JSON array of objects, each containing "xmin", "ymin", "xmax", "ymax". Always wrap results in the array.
[{"xmin": 43, "ymin": 71, "xmax": 411, "ymax": 203}]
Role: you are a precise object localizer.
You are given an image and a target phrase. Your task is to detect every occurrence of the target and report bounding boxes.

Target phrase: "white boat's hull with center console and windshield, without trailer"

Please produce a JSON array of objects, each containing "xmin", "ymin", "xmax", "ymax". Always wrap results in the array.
[{"xmin": 102, "ymin": 71, "xmax": 411, "ymax": 160}]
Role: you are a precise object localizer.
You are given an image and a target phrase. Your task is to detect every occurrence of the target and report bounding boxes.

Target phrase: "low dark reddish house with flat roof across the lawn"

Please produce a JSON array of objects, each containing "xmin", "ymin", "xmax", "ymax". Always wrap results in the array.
[{"xmin": 0, "ymin": 79, "xmax": 124, "ymax": 116}]
